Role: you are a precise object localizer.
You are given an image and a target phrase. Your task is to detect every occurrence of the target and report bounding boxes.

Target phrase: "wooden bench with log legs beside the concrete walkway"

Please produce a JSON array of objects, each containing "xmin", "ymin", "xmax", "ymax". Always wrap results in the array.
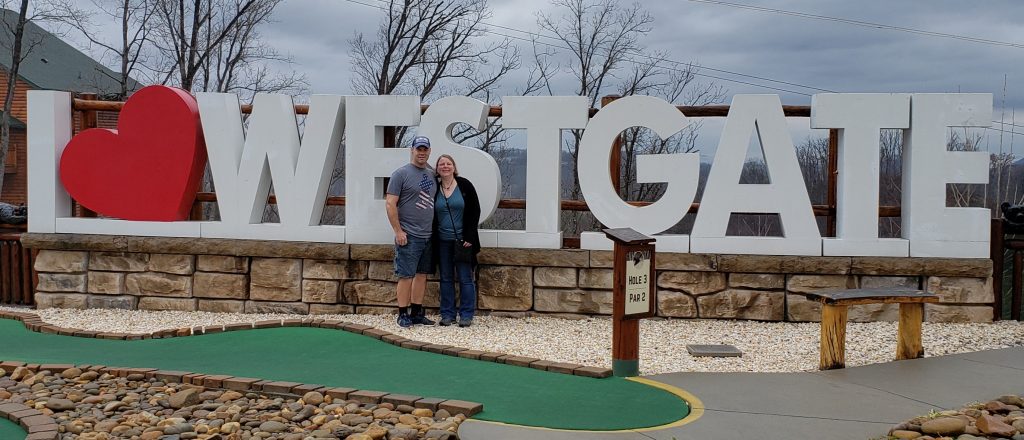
[{"xmin": 805, "ymin": 289, "xmax": 939, "ymax": 369}]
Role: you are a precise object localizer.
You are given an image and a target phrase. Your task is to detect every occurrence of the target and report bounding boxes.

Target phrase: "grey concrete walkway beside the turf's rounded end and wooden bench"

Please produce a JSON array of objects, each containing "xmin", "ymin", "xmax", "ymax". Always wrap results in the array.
[{"xmin": 459, "ymin": 347, "xmax": 1024, "ymax": 440}]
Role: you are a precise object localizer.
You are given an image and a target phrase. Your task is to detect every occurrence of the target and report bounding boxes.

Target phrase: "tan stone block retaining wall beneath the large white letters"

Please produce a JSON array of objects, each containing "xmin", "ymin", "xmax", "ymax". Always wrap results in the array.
[{"xmin": 22, "ymin": 233, "xmax": 994, "ymax": 322}]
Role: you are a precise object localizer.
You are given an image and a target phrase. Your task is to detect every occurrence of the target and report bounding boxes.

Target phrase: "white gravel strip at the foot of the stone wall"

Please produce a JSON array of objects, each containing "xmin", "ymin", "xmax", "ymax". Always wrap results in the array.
[{"xmin": 0, "ymin": 307, "xmax": 1024, "ymax": 375}]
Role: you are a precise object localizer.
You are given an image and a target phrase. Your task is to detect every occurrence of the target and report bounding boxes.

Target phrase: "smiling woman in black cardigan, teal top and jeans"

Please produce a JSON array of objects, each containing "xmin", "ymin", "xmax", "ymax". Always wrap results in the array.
[{"xmin": 432, "ymin": 155, "xmax": 480, "ymax": 327}]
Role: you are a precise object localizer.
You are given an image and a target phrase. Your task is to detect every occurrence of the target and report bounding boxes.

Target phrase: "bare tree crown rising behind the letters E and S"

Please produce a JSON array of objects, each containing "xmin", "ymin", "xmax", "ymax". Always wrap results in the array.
[{"xmin": 349, "ymin": 0, "xmax": 519, "ymax": 144}]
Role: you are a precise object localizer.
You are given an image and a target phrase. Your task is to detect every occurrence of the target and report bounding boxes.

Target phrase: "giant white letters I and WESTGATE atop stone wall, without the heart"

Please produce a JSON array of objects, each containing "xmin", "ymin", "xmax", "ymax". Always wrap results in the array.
[{"xmin": 29, "ymin": 91, "xmax": 992, "ymax": 258}]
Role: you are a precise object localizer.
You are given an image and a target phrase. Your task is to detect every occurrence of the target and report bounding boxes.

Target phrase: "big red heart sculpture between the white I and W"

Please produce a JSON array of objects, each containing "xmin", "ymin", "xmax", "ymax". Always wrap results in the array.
[{"xmin": 60, "ymin": 86, "xmax": 206, "ymax": 221}]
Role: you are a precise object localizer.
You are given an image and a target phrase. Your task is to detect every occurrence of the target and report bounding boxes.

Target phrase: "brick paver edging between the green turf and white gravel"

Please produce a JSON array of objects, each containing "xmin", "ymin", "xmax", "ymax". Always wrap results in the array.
[{"xmin": 0, "ymin": 310, "xmax": 611, "ymax": 378}]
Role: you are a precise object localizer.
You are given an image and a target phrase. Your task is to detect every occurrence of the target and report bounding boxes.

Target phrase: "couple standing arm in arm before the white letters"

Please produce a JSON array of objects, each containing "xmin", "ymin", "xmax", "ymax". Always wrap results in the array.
[{"xmin": 385, "ymin": 136, "xmax": 480, "ymax": 327}]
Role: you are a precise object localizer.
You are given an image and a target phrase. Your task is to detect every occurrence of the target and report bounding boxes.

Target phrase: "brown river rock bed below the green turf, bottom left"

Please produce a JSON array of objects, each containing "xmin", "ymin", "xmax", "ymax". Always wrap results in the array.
[{"xmin": 0, "ymin": 367, "xmax": 465, "ymax": 440}]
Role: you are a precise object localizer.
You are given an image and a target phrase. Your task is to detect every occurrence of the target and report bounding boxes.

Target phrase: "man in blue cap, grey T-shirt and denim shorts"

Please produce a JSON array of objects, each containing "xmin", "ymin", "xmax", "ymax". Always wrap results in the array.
[{"xmin": 385, "ymin": 136, "xmax": 437, "ymax": 327}]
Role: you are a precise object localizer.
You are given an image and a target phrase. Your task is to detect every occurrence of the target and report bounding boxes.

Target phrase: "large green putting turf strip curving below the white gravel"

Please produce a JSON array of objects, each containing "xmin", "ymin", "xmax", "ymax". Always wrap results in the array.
[{"xmin": 0, "ymin": 319, "xmax": 689, "ymax": 431}]
